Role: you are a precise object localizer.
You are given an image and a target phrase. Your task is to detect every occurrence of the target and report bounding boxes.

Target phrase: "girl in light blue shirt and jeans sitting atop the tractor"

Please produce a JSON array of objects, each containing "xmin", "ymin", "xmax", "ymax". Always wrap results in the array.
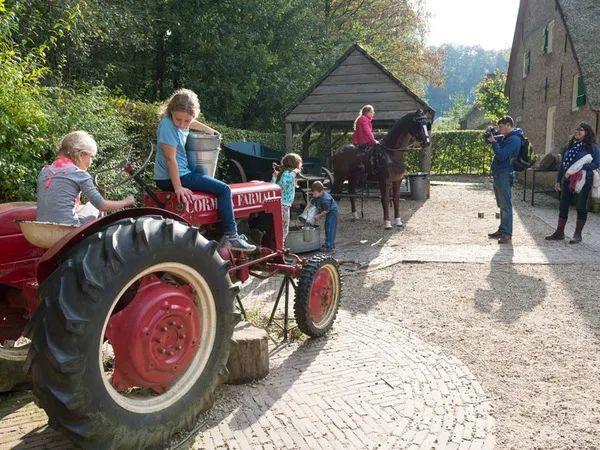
[{"xmin": 154, "ymin": 89, "xmax": 256, "ymax": 252}]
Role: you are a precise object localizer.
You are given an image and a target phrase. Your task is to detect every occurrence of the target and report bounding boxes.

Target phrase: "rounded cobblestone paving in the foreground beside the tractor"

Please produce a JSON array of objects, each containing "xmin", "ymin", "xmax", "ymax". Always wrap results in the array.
[{"xmin": 194, "ymin": 313, "xmax": 494, "ymax": 449}]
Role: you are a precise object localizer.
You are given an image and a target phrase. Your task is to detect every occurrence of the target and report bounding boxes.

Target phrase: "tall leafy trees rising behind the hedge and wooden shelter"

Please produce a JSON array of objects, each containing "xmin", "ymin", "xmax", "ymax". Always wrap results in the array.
[{"xmin": 7, "ymin": 0, "xmax": 441, "ymax": 129}]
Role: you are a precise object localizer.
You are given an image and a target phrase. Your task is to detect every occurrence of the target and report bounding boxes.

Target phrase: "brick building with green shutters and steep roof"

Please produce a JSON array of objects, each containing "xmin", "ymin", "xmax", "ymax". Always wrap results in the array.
[{"xmin": 506, "ymin": 0, "xmax": 600, "ymax": 160}]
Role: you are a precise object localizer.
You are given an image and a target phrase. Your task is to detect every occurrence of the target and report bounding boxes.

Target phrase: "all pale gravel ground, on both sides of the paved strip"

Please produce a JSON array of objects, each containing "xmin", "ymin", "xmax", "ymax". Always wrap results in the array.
[{"xmin": 241, "ymin": 179, "xmax": 600, "ymax": 448}]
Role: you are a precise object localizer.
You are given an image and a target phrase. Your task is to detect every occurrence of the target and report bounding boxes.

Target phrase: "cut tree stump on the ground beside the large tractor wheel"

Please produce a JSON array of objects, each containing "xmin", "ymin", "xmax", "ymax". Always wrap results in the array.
[{"xmin": 226, "ymin": 322, "xmax": 269, "ymax": 384}]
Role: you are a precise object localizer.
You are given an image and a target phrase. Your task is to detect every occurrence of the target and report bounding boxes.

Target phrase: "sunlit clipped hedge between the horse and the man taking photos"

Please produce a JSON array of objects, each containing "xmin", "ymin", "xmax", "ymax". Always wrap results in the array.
[{"xmin": 406, "ymin": 130, "xmax": 492, "ymax": 175}]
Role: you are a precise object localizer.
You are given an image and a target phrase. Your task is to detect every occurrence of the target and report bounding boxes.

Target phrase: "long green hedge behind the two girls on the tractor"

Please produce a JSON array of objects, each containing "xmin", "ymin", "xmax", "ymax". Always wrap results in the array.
[{"xmin": 0, "ymin": 89, "xmax": 285, "ymax": 203}]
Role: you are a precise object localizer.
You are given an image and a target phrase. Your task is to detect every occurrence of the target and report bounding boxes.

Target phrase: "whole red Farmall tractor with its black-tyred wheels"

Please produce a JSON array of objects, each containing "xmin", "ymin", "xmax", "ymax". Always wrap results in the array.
[{"xmin": 0, "ymin": 165, "xmax": 341, "ymax": 448}]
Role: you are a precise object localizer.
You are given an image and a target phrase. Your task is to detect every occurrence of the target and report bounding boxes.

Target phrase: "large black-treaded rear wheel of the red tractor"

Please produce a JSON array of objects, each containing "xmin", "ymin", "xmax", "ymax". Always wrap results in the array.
[{"xmin": 28, "ymin": 216, "xmax": 239, "ymax": 448}]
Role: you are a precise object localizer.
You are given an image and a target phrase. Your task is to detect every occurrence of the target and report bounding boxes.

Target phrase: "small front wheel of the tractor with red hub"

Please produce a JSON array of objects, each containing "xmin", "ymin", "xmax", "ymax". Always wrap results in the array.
[{"xmin": 294, "ymin": 255, "xmax": 342, "ymax": 337}]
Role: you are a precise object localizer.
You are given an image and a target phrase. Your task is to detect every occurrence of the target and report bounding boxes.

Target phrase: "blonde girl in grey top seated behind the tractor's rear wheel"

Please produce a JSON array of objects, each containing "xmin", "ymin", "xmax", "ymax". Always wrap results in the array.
[{"xmin": 36, "ymin": 131, "xmax": 135, "ymax": 226}]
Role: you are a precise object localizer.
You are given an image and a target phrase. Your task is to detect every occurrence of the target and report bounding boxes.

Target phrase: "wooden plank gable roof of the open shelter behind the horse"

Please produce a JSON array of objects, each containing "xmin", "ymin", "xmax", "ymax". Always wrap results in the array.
[{"xmin": 285, "ymin": 44, "xmax": 435, "ymax": 151}]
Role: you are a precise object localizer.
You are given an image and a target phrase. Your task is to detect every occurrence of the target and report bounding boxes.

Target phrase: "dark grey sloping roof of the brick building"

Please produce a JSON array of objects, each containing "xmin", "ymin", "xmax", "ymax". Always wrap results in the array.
[{"xmin": 558, "ymin": 0, "xmax": 600, "ymax": 111}]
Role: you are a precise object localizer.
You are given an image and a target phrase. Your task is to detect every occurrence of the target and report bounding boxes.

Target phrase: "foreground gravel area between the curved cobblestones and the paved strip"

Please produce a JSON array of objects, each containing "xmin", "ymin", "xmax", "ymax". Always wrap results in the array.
[{"xmin": 345, "ymin": 263, "xmax": 600, "ymax": 448}]
